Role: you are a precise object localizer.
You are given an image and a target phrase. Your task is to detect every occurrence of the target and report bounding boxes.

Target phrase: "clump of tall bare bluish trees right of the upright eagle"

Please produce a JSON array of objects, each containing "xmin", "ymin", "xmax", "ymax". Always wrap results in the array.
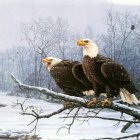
[{"xmin": 100, "ymin": 8, "xmax": 140, "ymax": 86}]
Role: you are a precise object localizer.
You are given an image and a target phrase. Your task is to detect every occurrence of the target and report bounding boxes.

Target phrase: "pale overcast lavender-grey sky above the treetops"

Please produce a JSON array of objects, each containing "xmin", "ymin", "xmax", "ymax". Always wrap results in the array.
[{"xmin": 0, "ymin": 0, "xmax": 140, "ymax": 51}]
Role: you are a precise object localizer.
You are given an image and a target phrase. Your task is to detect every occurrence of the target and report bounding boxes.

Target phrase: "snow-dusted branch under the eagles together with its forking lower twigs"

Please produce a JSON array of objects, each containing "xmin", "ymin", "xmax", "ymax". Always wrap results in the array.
[{"xmin": 11, "ymin": 76, "xmax": 140, "ymax": 140}]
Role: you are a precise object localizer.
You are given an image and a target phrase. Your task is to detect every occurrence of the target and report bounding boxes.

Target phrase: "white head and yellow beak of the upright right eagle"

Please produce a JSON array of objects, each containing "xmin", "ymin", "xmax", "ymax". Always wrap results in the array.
[{"xmin": 77, "ymin": 39, "xmax": 99, "ymax": 58}]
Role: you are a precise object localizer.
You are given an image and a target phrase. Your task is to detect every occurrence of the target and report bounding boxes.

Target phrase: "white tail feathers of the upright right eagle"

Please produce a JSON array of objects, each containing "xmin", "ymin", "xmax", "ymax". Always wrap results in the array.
[{"xmin": 120, "ymin": 88, "xmax": 139, "ymax": 105}]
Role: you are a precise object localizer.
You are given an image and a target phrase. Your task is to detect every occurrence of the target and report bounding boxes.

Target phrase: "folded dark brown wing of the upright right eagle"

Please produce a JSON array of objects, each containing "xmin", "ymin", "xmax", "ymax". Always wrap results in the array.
[{"xmin": 101, "ymin": 62, "xmax": 137, "ymax": 93}]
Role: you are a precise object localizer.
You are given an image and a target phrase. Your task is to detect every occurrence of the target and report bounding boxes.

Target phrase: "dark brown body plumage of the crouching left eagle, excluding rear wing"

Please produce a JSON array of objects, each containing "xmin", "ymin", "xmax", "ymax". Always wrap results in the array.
[{"xmin": 50, "ymin": 60, "xmax": 91, "ymax": 96}]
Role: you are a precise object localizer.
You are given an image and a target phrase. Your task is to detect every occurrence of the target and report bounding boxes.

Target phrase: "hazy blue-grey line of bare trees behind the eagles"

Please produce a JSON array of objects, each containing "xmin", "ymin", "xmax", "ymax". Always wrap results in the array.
[{"xmin": 0, "ymin": 9, "xmax": 140, "ymax": 96}]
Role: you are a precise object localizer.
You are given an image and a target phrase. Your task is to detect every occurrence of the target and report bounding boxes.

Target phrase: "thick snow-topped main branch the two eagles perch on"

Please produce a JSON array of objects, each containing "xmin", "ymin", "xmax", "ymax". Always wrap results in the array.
[{"xmin": 11, "ymin": 76, "xmax": 140, "ymax": 120}]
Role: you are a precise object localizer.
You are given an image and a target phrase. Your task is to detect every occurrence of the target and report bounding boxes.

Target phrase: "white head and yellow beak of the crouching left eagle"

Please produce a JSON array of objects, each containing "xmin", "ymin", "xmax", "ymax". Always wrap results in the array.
[{"xmin": 42, "ymin": 57, "xmax": 62, "ymax": 71}]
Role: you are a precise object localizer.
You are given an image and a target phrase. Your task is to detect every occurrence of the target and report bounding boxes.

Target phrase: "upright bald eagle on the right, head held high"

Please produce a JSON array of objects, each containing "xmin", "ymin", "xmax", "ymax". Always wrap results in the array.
[{"xmin": 77, "ymin": 39, "xmax": 138, "ymax": 106}]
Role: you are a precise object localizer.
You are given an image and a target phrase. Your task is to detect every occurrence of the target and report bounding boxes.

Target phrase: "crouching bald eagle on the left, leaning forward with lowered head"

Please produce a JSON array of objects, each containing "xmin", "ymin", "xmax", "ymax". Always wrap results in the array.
[{"xmin": 42, "ymin": 57, "xmax": 93, "ymax": 97}]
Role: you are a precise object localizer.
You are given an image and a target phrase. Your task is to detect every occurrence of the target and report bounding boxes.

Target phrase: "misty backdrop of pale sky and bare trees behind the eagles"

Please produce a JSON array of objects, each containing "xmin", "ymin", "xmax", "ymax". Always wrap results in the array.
[{"xmin": 0, "ymin": 0, "xmax": 140, "ymax": 98}]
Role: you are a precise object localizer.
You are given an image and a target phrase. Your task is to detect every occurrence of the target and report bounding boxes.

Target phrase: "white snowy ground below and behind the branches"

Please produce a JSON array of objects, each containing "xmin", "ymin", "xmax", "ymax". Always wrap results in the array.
[{"xmin": 0, "ymin": 92, "xmax": 140, "ymax": 140}]
